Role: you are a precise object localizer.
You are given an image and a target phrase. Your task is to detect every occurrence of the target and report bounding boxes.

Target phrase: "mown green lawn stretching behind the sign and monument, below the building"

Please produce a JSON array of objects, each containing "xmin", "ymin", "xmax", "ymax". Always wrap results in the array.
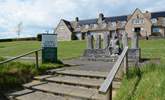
[{"xmin": 0, "ymin": 39, "xmax": 165, "ymax": 60}]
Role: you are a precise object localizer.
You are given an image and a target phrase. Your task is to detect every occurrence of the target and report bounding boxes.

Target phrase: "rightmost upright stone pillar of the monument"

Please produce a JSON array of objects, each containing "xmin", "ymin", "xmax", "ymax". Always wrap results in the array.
[{"xmin": 131, "ymin": 32, "xmax": 139, "ymax": 49}]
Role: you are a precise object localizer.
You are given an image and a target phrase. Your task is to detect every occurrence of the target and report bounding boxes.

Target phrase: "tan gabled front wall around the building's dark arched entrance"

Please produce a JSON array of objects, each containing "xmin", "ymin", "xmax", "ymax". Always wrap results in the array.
[{"xmin": 125, "ymin": 9, "xmax": 151, "ymax": 37}]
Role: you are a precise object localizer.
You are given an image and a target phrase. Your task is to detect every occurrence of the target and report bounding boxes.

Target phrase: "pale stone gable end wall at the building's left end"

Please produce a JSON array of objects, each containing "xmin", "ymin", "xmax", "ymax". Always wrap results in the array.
[{"xmin": 55, "ymin": 20, "xmax": 72, "ymax": 41}]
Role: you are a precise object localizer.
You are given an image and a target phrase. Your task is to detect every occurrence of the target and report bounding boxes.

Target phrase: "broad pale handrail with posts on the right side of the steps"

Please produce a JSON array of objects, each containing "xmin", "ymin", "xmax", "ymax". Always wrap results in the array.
[{"xmin": 99, "ymin": 47, "xmax": 128, "ymax": 100}]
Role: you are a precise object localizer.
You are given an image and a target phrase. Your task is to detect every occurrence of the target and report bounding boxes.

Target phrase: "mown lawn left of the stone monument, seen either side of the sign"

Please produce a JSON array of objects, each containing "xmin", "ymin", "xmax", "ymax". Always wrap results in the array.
[{"xmin": 0, "ymin": 41, "xmax": 85, "ymax": 59}]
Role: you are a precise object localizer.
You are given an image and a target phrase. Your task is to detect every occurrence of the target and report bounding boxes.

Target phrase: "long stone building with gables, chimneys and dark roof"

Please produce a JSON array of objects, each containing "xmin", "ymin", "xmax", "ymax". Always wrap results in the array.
[{"xmin": 54, "ymin": 8, "xmax": 165, "ymax": 41}]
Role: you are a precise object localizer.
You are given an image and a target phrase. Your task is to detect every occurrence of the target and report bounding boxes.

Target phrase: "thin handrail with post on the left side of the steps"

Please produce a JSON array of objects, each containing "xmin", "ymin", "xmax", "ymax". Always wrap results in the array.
[{"xmin": 0, "ymin": 49, "xmax": 42, "ymax": 69}]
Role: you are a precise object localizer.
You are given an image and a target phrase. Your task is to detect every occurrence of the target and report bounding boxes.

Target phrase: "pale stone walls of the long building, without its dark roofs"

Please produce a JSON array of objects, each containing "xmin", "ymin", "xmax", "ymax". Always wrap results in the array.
[{"xmin": 55, "ymin": 9, "xmax": 165, "ymax": 41}]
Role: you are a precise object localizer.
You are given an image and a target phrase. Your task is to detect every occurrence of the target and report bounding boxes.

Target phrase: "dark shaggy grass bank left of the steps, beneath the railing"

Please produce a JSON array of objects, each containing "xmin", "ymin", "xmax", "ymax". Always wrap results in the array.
[{"xmin": 0, "ymin": 58, "xmax": 63, "ymax": 91}]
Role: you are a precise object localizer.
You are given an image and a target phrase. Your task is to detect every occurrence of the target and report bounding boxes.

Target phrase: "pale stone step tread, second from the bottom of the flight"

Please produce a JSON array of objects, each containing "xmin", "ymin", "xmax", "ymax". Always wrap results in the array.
[{"xmin": 32, "ymin": 83, "xmax": 105, "ymax": 100}]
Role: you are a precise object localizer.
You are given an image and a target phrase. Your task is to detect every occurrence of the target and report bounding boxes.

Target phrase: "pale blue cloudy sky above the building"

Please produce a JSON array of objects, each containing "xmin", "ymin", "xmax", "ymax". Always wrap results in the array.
[{"xmin": 0, "ymin": 0, "xmax": 165, "ymax": 39}]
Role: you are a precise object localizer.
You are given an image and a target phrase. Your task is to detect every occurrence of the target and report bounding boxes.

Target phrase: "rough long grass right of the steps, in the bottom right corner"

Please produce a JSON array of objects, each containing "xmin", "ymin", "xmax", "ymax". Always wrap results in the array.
[{"xmin": 114, "ymin": 64, "xmax": 165, "ymax": 100}]
